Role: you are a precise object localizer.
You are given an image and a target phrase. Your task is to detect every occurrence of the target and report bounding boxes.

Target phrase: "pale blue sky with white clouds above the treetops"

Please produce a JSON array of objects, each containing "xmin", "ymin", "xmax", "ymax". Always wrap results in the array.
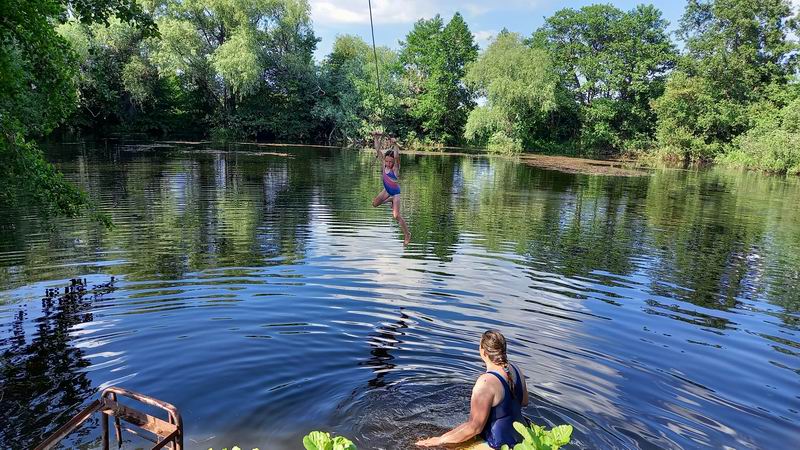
[{"xmin": 309, "ymin": 0, "xmax": 688, "ymax": 59}]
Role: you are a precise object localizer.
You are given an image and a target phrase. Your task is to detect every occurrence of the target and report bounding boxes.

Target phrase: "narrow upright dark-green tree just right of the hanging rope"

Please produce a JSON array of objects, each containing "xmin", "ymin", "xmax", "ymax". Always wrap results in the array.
[{"xmin": 400, "ymin": 13, "xmax": 478, "ymax": 144}]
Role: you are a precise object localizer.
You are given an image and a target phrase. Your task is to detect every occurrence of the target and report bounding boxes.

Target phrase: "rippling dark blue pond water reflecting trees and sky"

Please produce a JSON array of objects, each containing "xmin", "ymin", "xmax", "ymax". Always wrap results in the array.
[{"xmin": 0, "ymin": 144, "xmax": 800, "ymax": 450}]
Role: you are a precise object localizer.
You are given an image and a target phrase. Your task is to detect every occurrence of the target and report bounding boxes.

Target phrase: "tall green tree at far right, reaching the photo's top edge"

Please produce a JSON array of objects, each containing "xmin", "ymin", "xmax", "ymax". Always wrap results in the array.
[{"xmin": 654, "ymin": 0, "xmax": 798, "ymax": 161}]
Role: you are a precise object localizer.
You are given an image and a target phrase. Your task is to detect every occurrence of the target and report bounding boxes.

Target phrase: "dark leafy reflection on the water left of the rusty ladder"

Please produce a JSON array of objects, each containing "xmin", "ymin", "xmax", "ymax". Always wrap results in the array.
[{"xmin": 0, "ymin": 286, "xmax": 114, "ymax": 448}]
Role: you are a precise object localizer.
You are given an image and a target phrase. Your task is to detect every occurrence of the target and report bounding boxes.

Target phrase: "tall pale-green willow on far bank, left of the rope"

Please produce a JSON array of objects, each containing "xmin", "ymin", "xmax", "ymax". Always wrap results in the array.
[{"xmin": 150, "ymin": 0, "xmax": 317, "ymax": 140}]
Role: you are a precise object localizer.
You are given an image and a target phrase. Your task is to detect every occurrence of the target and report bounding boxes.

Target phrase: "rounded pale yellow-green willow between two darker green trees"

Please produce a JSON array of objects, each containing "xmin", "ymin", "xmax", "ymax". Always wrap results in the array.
[{"xmin": 464, "ymin": 32, "xmax": 557, "ymax": 153}]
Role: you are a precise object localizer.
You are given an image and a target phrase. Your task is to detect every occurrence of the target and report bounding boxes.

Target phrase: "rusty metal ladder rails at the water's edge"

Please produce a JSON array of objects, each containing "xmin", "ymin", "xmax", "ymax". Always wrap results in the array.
[{"xmin": 35, "ymin": 387, "xmax": 183, "ymax": 450}]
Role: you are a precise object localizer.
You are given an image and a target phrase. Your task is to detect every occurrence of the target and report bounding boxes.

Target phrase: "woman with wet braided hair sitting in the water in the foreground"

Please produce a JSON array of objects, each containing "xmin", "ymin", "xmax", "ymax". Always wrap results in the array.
[{"xmin": 417, "ymin": 330, "xmax": 528, "ymax": 449}]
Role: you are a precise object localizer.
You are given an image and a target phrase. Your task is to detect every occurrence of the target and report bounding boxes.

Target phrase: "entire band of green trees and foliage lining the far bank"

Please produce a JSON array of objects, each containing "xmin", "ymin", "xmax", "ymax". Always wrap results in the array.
[{"xmin": 0, "ymin": 0, "xmax": 800, "ymax": 221}]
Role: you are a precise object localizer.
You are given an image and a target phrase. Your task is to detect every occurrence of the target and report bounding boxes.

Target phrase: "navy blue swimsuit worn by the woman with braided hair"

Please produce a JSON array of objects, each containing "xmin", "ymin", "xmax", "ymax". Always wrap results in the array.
[{"xmin": 481, "ymin": 366, "xmax": 525, "ymax": 449}]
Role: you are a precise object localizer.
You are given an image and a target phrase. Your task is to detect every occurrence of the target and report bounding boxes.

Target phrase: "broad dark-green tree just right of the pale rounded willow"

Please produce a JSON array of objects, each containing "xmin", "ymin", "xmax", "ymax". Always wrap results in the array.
[{"xmin": 533, "ymin": 5, "xmax": 677, "ymax": 154}]
